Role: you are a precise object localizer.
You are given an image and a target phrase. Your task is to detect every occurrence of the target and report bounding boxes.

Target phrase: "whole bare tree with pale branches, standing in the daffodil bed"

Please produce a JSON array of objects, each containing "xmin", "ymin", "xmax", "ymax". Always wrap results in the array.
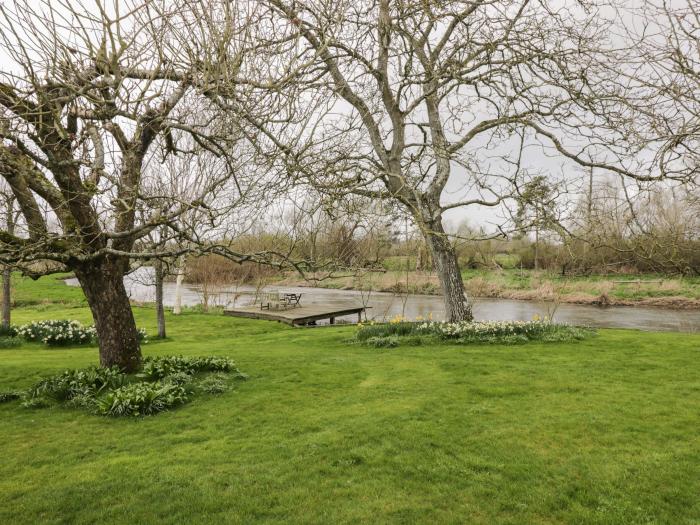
[{"xmin": 241, "ymin": 0, "xmax": 672, "ymax": 320}]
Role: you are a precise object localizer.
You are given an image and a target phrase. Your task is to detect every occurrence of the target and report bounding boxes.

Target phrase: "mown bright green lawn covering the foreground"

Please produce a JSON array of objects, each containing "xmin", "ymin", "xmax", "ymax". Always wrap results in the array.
[{"xmin": 0, "ymin": 281, "xmax": 700, "ymax": 524}]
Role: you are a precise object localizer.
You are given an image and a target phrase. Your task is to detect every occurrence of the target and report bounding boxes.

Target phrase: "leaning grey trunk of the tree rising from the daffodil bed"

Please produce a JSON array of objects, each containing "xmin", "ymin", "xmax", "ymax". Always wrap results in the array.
[{"xmin": 424, "ymin": 219, "xmax": 474, "ymax": 322}]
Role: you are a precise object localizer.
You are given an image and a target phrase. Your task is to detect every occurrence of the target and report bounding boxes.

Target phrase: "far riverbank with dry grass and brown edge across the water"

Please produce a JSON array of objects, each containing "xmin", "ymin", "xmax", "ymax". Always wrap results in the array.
[{"xmin": 271, "ymin": 269, "xmax": 700, "ymax": 310}]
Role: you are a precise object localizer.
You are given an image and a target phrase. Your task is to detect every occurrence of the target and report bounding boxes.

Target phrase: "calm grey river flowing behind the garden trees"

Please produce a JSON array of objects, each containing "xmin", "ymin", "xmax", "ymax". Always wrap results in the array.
[{"xmin": 66, "ymin": 268, "xmax": 700, "ymax": 332}]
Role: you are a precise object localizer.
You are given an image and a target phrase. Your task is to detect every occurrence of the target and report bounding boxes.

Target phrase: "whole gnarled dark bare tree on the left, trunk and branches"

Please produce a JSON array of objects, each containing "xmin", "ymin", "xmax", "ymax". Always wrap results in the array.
[{"xmin": 0, "ymin": 0, "xmax": 266, "ymax": 370}]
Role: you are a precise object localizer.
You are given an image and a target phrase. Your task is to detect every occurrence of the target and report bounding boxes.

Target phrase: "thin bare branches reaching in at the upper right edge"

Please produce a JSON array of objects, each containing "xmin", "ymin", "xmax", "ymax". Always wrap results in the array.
[{"xmin": 624, "ymin": 0, "xmax": 700, "ymax": 186}]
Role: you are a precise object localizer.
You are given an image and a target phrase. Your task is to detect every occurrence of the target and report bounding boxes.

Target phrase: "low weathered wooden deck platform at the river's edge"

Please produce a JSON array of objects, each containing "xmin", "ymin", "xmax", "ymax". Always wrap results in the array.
[{"xmin": 224, "ymin": 304, "xmax": 365, "ymax": 326}]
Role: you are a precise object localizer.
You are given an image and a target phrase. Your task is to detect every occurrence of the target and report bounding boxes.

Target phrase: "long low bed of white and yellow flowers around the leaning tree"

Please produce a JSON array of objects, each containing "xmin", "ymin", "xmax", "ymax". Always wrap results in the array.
[{"xmin": 355, "ymin": 320, "xmax": 595, "ymax": 346}]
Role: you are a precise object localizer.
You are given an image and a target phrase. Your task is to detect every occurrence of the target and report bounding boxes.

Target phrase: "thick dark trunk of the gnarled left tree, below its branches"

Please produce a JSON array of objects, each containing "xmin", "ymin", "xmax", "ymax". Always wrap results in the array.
[{"xmin": 75, "ymin": 258, "xmax": 141, "ymax": 372}]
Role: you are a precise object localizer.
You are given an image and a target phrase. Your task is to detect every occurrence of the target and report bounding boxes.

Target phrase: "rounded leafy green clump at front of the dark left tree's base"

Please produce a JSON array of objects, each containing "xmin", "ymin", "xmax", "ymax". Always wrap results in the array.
[{"xmin": 95, "ymin": 381, "xmax": 189, "ymax": 416}]
